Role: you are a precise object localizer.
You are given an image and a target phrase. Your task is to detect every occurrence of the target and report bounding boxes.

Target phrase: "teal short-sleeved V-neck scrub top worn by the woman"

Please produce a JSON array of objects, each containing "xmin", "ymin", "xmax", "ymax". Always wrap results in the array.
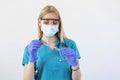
[{"xmin": 22, "ymin": 38, "xmax": 80, "ymax": 80}]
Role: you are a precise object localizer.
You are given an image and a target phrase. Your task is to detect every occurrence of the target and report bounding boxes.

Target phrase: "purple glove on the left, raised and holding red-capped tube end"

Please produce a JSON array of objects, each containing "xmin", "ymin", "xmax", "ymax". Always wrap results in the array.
[{"xmin": 28, "ymin": 40, "xmax": 41, "ymax": 62}]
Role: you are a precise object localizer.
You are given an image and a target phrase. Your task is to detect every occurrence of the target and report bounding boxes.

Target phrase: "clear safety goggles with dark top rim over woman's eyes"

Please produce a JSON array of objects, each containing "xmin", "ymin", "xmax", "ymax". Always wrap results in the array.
[{"xmin": 41, "ymin": 18, "xmax": 60, "ymax": 25}]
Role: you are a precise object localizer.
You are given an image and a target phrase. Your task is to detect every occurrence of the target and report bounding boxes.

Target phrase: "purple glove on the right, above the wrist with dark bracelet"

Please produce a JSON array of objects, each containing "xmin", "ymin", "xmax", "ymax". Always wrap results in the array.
[{"xmin": 59, "ymin": 48, "xmax": 78, "ymax": 66}]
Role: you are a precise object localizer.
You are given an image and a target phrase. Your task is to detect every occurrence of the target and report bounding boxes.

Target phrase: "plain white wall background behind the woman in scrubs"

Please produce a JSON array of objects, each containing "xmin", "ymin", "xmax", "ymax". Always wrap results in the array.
[{"xmin": 0, "ymin": 0, "xmax": 120, "ymax": 80}]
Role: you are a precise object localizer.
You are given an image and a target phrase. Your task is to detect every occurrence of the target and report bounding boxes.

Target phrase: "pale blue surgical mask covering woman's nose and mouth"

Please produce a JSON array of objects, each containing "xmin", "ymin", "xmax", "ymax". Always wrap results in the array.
[{"xmin": 41, "ymin": 24, "xmax": 59, "ymax": 37}]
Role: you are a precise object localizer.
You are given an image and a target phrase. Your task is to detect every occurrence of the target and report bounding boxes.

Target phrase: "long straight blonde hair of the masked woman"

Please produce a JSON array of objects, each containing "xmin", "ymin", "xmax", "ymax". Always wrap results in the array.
[{"xmin": 38, "ymin": 5, "xmax": 66, "ymax": 42}]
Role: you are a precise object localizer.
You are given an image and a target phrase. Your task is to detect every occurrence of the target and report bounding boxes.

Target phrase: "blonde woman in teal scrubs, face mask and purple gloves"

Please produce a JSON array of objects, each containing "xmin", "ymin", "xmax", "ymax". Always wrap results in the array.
[{"xmin": 22, "ymin": 6, "xmax": 81, "ymax": 80}]
